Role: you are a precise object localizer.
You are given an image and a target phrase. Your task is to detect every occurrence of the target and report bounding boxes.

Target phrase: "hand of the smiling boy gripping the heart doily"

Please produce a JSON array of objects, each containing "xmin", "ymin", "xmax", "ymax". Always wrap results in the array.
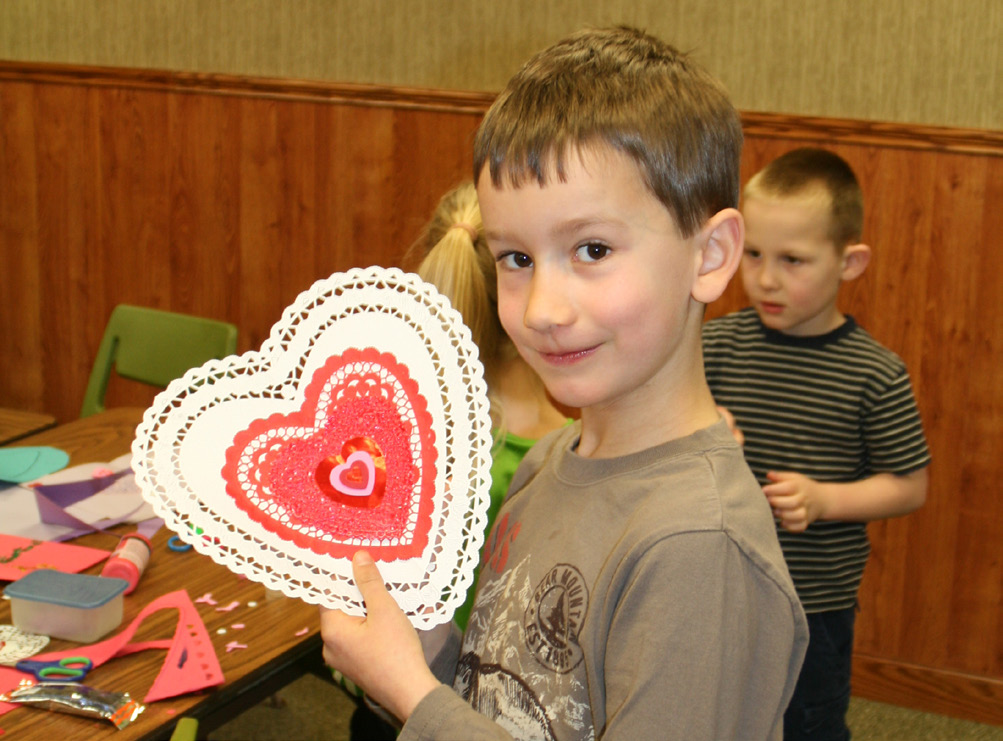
[{"xmin": 320, "ymin": 550, "xmax": 439, "ymax": 721}]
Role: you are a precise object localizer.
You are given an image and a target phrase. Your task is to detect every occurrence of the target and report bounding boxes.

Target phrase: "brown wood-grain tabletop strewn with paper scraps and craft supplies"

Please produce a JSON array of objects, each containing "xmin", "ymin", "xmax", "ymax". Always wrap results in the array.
[{"xmin": 0, "ymin": 408, "xmax": 324, "ymax": 741}]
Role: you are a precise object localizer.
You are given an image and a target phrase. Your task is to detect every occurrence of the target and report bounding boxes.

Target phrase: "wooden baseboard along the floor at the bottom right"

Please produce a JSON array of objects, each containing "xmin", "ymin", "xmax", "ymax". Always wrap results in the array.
[{"xmin": 853, "ymin": 653, "xmax": 1003, "ymax": 726}]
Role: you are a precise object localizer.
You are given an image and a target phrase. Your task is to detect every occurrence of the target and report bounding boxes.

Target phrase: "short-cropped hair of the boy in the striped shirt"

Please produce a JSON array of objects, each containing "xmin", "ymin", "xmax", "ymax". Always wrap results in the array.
[{"xmin": 745, "ymin": 146, "xmax": 864, "ymax": 250}]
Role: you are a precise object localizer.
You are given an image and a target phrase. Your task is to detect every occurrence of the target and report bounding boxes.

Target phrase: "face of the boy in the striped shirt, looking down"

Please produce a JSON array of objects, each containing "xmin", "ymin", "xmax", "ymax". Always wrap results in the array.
[{"xmin": 741, "ymin": 196, "xmax": 846, "ymax": 337}]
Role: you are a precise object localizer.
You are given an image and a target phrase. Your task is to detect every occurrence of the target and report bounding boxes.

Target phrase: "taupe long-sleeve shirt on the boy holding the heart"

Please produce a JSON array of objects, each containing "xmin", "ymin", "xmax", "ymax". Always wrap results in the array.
[{"xmin": 400, "ymin": 422, "xmax": 807, "ymax": 741}]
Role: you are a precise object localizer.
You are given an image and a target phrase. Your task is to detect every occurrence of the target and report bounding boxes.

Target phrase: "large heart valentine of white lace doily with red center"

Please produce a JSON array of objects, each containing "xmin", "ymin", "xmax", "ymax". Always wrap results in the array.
[{"xmin": 132, "ymin": 268, "xmax": 491, "ymax": 628}]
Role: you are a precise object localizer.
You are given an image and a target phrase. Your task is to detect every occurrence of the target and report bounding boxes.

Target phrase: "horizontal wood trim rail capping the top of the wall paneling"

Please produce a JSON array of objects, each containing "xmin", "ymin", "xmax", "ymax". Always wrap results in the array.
[{"xmin": 0, "ymin": 60, "xmax": 1003, "ymax": 156}]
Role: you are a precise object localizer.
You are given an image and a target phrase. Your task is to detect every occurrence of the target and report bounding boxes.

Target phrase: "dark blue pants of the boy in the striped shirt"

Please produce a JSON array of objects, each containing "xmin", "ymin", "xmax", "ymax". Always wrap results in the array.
[{"xmin": 783, "ymin": 608, "xmax": 857, "ymax": 741}]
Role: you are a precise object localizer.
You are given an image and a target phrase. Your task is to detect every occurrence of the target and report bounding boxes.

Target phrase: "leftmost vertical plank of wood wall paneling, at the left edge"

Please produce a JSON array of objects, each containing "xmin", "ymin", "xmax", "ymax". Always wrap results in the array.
[{"xmin": 0, "ymin": 83, "xmax": 45, "ymax": 410}]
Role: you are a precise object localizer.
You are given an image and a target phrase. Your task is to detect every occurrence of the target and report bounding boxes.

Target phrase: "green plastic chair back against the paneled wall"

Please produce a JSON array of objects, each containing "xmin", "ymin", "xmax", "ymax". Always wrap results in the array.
[{"xmin": 80, "ymin": 304, "xmax": 237, "ymax": 417}]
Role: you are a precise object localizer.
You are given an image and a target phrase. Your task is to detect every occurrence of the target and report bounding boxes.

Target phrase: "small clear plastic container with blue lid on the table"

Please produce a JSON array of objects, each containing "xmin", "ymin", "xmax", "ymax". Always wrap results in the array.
[{"xmin": 4, "ymin": 569, "xmax": 128, "ymax": 643}]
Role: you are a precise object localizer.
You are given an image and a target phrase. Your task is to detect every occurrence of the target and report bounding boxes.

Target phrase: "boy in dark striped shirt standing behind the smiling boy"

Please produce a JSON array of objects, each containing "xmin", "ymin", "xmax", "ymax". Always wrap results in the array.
[{"xmin": 703, "ymin": 148, "xmax": 930, "ymax": 741}]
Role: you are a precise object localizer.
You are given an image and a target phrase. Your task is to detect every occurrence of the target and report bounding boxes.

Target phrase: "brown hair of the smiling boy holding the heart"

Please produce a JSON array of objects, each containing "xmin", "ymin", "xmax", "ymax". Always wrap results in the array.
[{"xmin": 473, "ymin": 26, "xmax": 742, "ymax": 237}]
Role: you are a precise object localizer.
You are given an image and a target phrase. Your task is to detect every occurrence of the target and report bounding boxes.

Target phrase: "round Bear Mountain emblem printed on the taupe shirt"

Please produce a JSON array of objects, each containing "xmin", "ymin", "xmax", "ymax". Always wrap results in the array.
[{"xmin": 524, "ymin": 564, "xmax": 589, "ymax": 674}]
